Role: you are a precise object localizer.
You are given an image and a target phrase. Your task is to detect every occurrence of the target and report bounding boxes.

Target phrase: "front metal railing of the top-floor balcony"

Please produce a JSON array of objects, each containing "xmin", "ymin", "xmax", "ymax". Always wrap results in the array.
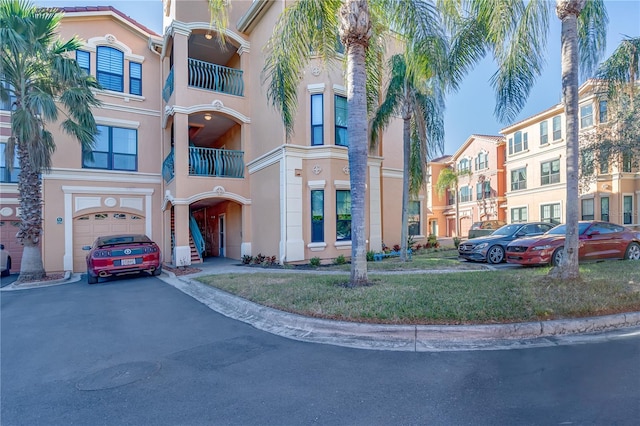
[{"xmin": 189, "ymin": 59, "xmax": 244, "ymax": 96}]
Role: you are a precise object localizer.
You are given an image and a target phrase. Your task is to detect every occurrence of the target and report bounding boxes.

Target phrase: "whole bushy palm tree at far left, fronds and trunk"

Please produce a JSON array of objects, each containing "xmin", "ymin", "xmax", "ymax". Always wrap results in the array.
[{"xmin": 0, "ymin": 0, "xmax": 99, "ymax": 282}]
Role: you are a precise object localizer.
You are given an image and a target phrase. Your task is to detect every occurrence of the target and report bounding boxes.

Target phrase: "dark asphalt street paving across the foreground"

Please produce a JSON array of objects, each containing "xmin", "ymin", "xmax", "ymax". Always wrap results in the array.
[{"xmin": 0, "ymin": 277, "xmax": 640, "ymax": 426}]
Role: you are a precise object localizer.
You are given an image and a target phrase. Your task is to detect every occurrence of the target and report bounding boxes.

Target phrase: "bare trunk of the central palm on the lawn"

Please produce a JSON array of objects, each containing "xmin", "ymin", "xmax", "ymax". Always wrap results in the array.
[{"xmin": 340, "ymin": 0, "xmax": 371, "ymax": 286}]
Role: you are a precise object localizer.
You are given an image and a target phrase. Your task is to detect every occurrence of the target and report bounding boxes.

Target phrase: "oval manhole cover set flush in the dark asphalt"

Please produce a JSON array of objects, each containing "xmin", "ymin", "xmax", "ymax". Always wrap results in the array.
[{"xmin": 76, "ymin": 361, "xmax": 160, "ymax": 391}]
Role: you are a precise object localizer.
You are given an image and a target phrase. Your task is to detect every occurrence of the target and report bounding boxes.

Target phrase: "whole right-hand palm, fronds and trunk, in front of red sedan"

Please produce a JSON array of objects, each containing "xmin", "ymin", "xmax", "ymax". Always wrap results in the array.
[{"xmin": 447, "ymin": 0, "xmax": 608, "ymax": 279}]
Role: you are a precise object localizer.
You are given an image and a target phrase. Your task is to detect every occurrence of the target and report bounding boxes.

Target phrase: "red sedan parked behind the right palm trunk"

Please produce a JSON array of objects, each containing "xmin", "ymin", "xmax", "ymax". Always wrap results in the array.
[{"xmin": 507, "ymin": 221, "xmax": 640, "ymax": 266}]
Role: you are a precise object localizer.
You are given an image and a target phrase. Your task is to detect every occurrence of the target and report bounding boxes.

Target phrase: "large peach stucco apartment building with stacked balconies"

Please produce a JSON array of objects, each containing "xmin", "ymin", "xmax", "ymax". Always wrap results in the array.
[{"xmin": 0, "ymin": 0, "xmax": 428, "ymax": 272}]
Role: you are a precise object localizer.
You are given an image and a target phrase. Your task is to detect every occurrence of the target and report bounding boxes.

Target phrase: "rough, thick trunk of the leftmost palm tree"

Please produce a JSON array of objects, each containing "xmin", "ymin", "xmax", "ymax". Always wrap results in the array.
[{"xmin": 16, "ymin": 141, "xmax": 46, "ymax": 283}]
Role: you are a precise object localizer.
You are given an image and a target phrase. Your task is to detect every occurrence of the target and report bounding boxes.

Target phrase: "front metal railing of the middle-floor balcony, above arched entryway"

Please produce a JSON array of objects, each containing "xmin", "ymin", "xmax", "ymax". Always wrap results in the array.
[{"xmin": 189, "ymin": 146, "xmax": 244, "ymax": 178}]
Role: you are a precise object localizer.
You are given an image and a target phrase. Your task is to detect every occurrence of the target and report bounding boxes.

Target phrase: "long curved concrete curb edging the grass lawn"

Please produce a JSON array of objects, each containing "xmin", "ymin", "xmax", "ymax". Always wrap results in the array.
[{"xmin": 161, "ymin": 273, "xmax": 640, "ymax": 352}]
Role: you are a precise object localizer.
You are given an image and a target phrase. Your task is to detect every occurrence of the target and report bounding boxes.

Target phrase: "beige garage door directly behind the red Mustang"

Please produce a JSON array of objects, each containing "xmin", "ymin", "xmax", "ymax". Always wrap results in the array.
[{"xmin": 73, "ymin": 212, "xmax": 145, "ymax": 272}]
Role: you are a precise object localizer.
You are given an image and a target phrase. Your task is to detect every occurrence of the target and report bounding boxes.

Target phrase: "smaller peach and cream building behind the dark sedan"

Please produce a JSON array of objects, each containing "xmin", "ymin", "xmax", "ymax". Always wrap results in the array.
[{"xmin": 444, "ymin": 135, "xmax": 505, "ymax": 237}]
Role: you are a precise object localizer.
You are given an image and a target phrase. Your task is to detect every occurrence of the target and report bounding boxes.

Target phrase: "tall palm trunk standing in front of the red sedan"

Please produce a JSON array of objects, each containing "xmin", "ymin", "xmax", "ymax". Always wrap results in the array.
[{"xmin": 550, "ymin": 0, "xmax": 586, "ymax": 279}]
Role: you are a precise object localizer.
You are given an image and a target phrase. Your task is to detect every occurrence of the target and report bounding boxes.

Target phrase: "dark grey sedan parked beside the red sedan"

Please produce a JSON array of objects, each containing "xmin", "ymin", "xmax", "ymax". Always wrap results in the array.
[{"xmin": 458, "ymin": 222, "xmax": 555, "ymax": 263}]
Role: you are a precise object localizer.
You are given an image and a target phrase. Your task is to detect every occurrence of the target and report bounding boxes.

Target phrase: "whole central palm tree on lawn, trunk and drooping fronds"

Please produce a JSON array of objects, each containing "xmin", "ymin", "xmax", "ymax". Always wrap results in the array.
[{"xmin": 263, "ymin": 0, "xmax": 448, "ymax": 286}]
